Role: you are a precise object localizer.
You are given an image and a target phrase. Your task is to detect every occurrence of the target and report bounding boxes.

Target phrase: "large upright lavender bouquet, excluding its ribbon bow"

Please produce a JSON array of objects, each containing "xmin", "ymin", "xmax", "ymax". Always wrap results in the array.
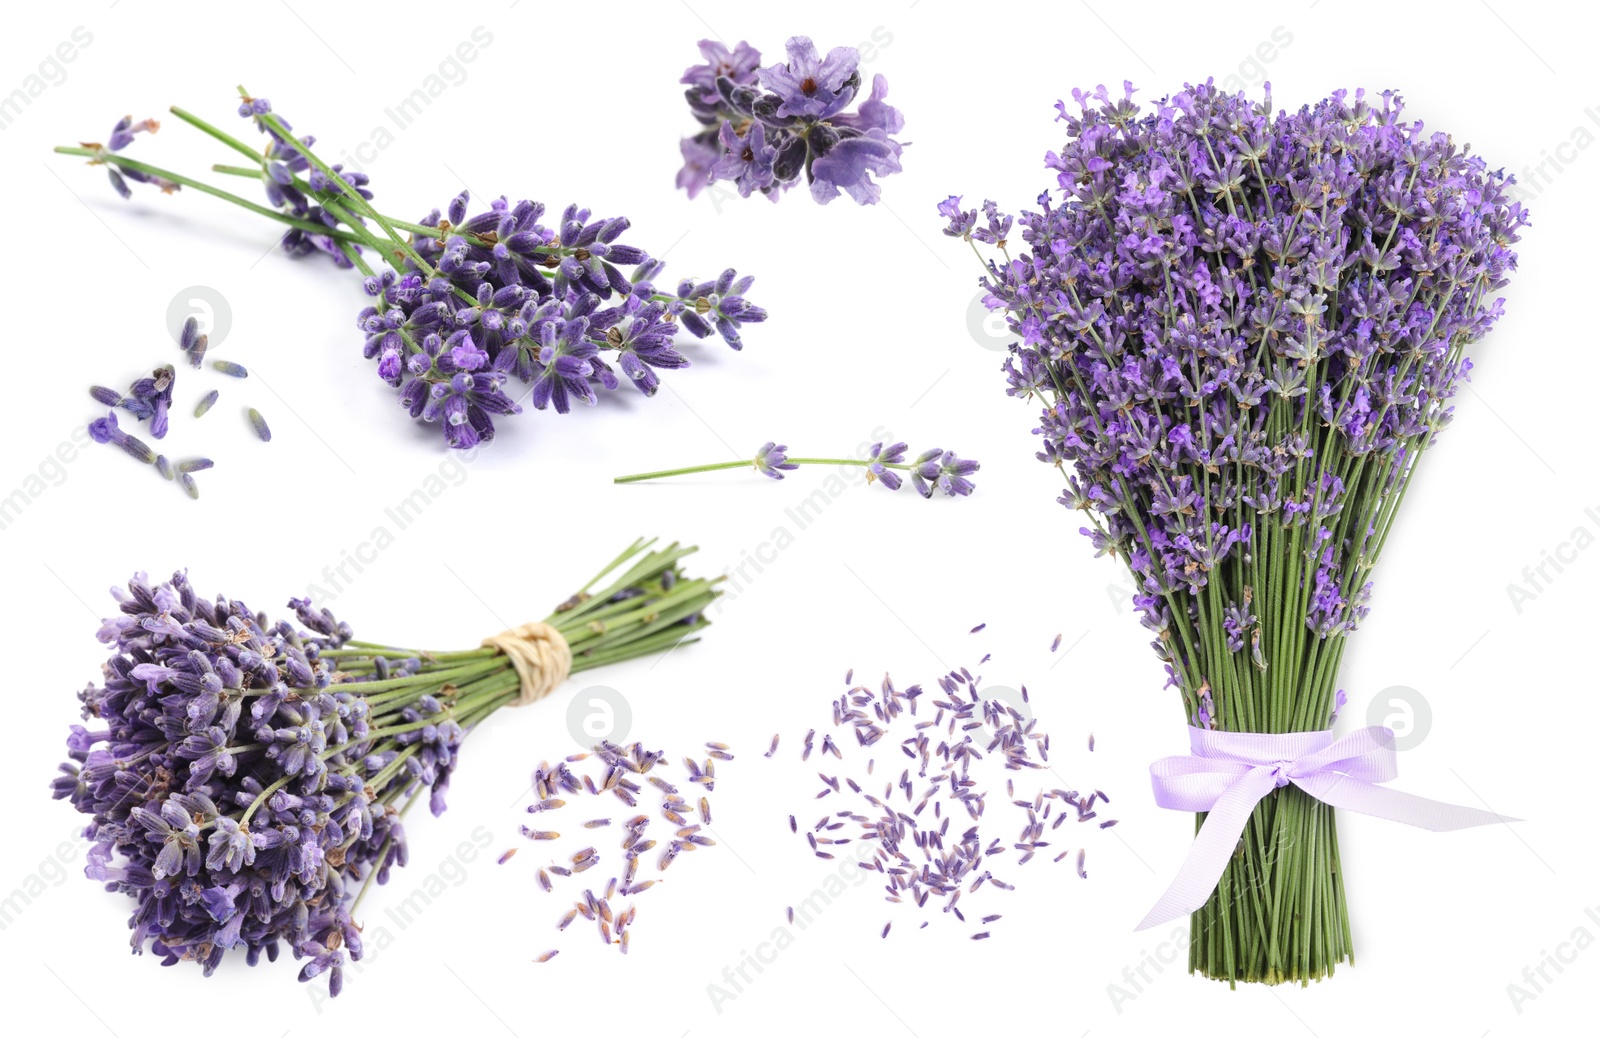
[{"xmin": 939, "ymin": 82, "xmax": 1526, "ymax": 982}]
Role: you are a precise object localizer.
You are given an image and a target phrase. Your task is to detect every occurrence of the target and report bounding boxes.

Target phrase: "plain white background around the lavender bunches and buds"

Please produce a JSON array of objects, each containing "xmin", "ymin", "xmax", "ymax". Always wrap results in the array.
[{"xmin": 0, "ymin": 0, "xmax": 1600, "ymax": 1038}]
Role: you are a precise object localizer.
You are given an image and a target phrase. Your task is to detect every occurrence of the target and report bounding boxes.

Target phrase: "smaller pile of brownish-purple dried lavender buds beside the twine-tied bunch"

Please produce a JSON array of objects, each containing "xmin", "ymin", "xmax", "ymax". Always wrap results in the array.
[{"xmin": 499, "ymin": 741, "xmax": 733, "ymax": 963}]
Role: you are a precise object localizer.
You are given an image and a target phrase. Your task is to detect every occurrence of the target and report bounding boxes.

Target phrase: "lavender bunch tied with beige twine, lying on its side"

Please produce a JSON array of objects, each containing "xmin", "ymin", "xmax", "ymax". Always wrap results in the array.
[{"xmin": 53, "ymin": 541, "xmax": 718, "ymax": 995}]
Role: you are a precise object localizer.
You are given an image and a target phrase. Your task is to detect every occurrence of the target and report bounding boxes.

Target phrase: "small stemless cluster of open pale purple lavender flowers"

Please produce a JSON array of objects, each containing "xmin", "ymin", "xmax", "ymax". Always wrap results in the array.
[{"xmin": 678, "ymin": 37, "xmax": 906, "ymax": 205}]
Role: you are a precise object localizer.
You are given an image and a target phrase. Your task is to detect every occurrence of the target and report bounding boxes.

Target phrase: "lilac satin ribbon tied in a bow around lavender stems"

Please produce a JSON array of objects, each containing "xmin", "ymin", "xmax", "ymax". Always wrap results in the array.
[{"xmin": 1138, "ymin": 726, "xmax": 1518, "ymax": 929}]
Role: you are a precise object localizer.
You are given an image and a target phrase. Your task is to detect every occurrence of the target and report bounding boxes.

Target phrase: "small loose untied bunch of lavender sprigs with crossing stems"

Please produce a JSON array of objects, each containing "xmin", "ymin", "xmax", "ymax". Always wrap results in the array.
[{"xmin": 56, "ymin": 97, "xmax": 766, "ymax": 449}]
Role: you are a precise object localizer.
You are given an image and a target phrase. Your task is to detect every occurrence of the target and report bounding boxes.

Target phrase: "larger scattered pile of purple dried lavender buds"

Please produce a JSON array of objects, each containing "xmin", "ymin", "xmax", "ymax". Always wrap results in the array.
[{"xmin": 766, "ymin": 655, "xmax": 1117, "ymax": 940}]
